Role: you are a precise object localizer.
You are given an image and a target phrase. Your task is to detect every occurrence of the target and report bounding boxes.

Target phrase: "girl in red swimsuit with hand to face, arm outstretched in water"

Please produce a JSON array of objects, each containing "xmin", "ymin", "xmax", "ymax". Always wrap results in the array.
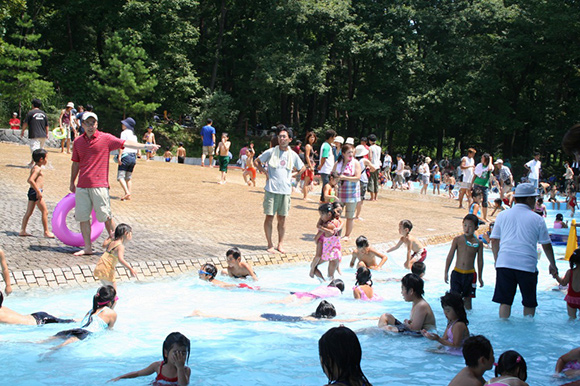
[{"xmin": 109, "ymin": 332, "xmax": 191, "ymax": 386}]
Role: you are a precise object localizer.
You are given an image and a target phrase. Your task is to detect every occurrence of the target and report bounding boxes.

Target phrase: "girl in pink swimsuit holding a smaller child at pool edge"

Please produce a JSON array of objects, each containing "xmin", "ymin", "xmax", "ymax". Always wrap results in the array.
[{"xmin": 310, "ymin": 204, "xmax": 342, "ymax": 280}]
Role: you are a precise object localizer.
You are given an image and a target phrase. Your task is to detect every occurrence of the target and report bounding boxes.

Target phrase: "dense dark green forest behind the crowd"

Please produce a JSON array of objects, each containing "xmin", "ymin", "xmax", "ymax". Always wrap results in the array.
[{"xmin": 0, "ymin": 0, "xmax": 580, "ymax": 175}]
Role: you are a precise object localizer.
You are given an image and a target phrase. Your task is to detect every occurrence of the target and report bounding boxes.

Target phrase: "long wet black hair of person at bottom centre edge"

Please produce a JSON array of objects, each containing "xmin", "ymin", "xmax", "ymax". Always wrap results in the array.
[{"xmin": 318, "ymin": 326, "xmax": 372, "ymax": 386}]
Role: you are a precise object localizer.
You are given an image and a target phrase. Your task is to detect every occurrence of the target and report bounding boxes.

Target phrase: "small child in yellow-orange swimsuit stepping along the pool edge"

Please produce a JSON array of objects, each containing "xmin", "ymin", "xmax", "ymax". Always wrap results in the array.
[{"xmin": 93, "ymin": 224, "xmax": 137, "ymax": 290}]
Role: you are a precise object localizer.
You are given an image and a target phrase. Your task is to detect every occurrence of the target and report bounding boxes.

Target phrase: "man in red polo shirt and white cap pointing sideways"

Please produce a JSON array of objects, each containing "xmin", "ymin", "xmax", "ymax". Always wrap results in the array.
[{"xmin": 70, "ymin": 112, "xmax": 159, "ymax": 256}]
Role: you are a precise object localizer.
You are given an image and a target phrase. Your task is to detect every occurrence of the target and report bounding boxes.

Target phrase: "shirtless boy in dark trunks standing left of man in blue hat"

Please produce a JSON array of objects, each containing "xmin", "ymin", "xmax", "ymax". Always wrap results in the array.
[{"xmin": 445, "ymin": 214, "xmax": 483, "ymax": 310}]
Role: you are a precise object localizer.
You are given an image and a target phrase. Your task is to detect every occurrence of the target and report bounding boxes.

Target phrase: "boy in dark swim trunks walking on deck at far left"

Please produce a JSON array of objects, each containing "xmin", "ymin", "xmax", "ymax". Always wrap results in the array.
[{"xmin": 18, "ymin": 149, "xmax": 54, "ymax": 239}]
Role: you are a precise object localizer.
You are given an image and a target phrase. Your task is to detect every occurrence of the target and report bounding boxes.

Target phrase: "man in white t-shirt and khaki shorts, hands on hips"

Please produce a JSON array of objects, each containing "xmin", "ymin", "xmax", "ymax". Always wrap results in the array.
[{"xmin": 254, "ymin": 125, "xmax": 306, "ymax": 253}]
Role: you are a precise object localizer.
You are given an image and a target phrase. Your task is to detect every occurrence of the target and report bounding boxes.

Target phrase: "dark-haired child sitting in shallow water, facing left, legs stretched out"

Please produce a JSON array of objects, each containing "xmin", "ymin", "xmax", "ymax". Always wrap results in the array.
[{"xmin": 378, "ymin": 273, "xmax": 437, "ymax": 336}]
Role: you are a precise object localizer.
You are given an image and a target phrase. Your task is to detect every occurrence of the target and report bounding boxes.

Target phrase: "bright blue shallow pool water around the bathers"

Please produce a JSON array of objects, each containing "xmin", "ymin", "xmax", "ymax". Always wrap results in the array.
[{"xmin": 0, "ymin": 235, "xmax": 580, "ymax": 386}]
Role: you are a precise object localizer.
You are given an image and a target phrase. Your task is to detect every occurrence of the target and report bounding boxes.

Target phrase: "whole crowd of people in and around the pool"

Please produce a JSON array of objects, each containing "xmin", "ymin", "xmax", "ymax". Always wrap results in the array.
[{"xmin": 0, "ymin": 100, "xmax": 580, "ymax": 386}]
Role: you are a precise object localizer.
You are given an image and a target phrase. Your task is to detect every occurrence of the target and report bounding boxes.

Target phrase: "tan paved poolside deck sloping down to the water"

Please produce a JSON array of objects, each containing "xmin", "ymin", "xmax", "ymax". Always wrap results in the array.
[{"xmin": 0, "ymin": 143, "xmax": 466, "ymax": 291}]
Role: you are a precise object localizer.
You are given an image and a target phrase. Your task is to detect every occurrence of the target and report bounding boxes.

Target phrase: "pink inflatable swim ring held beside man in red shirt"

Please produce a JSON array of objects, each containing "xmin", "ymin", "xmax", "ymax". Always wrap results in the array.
[{"xmin": 51, "ymin": 193, "xmax": 105, "ymax": 247}]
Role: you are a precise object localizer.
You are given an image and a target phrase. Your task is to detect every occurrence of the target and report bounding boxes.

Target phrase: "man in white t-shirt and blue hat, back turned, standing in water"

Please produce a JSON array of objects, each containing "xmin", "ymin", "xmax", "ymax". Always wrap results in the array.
[{"xmin": 490, "ymin": 184, "xmax": 558, "ymax": 318}]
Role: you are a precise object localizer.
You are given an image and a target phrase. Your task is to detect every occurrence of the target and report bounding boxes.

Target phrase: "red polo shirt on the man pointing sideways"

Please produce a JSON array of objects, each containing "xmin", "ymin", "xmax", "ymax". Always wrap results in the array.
[{"xmin": 71, "ymin": 130, "xmax": 125, "ymax": 188}]
